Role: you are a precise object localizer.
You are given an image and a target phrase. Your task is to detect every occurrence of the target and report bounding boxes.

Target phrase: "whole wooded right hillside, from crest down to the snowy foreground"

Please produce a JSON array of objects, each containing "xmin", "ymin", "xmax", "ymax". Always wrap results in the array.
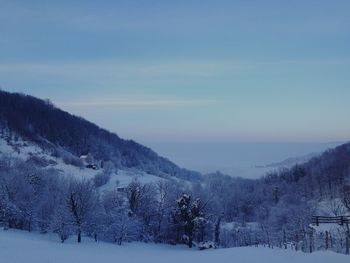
[{"xmin": 201, "ymin": 143, "xmax": 350, "ymax": 253}]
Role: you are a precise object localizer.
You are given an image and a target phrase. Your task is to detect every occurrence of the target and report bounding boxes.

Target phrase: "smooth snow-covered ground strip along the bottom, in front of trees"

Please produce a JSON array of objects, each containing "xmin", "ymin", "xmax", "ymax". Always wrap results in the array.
[{"xmin": 0, "ymin": 230, "xmax": 350, "ymax": 263}]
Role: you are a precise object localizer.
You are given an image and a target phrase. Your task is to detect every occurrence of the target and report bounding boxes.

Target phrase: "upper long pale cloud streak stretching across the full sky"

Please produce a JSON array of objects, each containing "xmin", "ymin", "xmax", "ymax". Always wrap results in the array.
[{"xmin": 0, "ymin": 58, "xmax": 350, "ymax": 78}]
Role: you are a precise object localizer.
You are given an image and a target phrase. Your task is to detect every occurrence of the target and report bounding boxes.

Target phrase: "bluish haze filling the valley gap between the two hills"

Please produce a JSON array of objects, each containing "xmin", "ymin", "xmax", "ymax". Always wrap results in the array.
[{"xmin": 148, "ymin": 142, "xmax": 342, "ymax": 179}]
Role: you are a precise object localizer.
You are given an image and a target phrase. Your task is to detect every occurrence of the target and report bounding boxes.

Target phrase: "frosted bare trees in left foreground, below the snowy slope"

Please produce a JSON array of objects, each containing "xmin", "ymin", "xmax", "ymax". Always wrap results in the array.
[{"xmin": 0, "ymin": 157, "xmax": 215, "ymax": 250}]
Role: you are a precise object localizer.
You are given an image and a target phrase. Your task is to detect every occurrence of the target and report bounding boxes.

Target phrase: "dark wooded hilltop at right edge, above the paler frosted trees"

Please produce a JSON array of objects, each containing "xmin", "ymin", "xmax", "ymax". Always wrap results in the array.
[{"xmin": 262, "ymin": 143, "xmax": 350, "ymax": 200}]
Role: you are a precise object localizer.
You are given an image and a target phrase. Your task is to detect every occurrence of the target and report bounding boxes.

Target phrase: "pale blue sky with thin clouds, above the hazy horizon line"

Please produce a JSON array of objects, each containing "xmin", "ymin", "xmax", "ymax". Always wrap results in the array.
[{"xmin": 0, "ymin": 0, "xmax": 350, "ymax": 143}]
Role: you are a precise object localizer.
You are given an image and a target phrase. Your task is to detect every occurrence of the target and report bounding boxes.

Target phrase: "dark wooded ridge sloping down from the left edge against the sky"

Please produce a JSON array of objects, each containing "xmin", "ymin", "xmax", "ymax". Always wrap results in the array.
[{"xmin": 0, "ymin": 91, "xmax": 201, "ymax": 180}]
